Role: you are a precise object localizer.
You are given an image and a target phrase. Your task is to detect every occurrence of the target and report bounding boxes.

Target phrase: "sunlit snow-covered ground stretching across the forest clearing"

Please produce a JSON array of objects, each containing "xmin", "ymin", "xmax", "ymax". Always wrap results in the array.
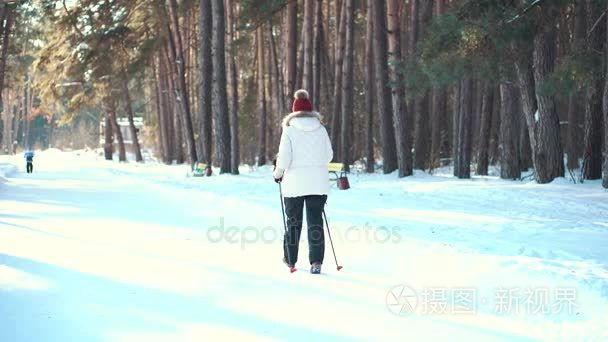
[{"xmin": 0, "ymin": 150, "xmax": 608, "ymax": 342}]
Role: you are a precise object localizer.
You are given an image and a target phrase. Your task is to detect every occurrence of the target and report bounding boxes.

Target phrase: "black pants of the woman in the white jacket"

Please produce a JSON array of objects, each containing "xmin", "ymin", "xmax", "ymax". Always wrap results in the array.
[{"xmin": 283, "ymin": 195, "xmax": 327, "ymax": 265}]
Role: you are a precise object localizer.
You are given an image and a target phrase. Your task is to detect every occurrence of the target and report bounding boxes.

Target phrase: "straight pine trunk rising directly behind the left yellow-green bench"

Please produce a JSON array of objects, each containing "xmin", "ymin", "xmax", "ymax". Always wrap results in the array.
[{"xmin": 198, "ymin": 0, "xmax": 213, "ymax": 165}]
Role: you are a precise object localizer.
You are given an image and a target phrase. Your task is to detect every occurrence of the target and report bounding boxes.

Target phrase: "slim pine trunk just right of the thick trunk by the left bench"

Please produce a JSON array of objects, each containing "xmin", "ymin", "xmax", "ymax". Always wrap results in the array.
[{"xmin": 226, "ymin": 0, "xmax": 241, "ymax": 175}]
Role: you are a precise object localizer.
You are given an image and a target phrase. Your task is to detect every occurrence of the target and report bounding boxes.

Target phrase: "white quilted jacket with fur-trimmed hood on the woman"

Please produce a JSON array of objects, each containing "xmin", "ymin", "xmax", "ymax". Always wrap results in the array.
[{"xmin": 274, "ymin": 112, "xmax": 334, "ymax": 197}]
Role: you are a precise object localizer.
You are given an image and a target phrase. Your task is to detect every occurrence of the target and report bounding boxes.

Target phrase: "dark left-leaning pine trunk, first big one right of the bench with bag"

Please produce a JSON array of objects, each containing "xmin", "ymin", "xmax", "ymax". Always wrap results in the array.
[{"xmin": 372, "ymin": 1, "xmax": 397, "ymax": 174}]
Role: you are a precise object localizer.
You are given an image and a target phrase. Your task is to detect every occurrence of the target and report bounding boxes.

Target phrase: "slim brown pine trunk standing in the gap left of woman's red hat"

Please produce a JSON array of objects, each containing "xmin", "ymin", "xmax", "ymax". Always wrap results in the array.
[{"xmin": 256, "ymin": 27, "xmax": 268, "ymax": 166}]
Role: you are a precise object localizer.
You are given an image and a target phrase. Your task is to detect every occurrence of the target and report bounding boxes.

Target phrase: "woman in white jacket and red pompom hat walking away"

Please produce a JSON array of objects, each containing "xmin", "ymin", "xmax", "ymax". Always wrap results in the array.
[{"xmin": 273, "ymin": 90, "xmax": 333, "ymax": 274}]
